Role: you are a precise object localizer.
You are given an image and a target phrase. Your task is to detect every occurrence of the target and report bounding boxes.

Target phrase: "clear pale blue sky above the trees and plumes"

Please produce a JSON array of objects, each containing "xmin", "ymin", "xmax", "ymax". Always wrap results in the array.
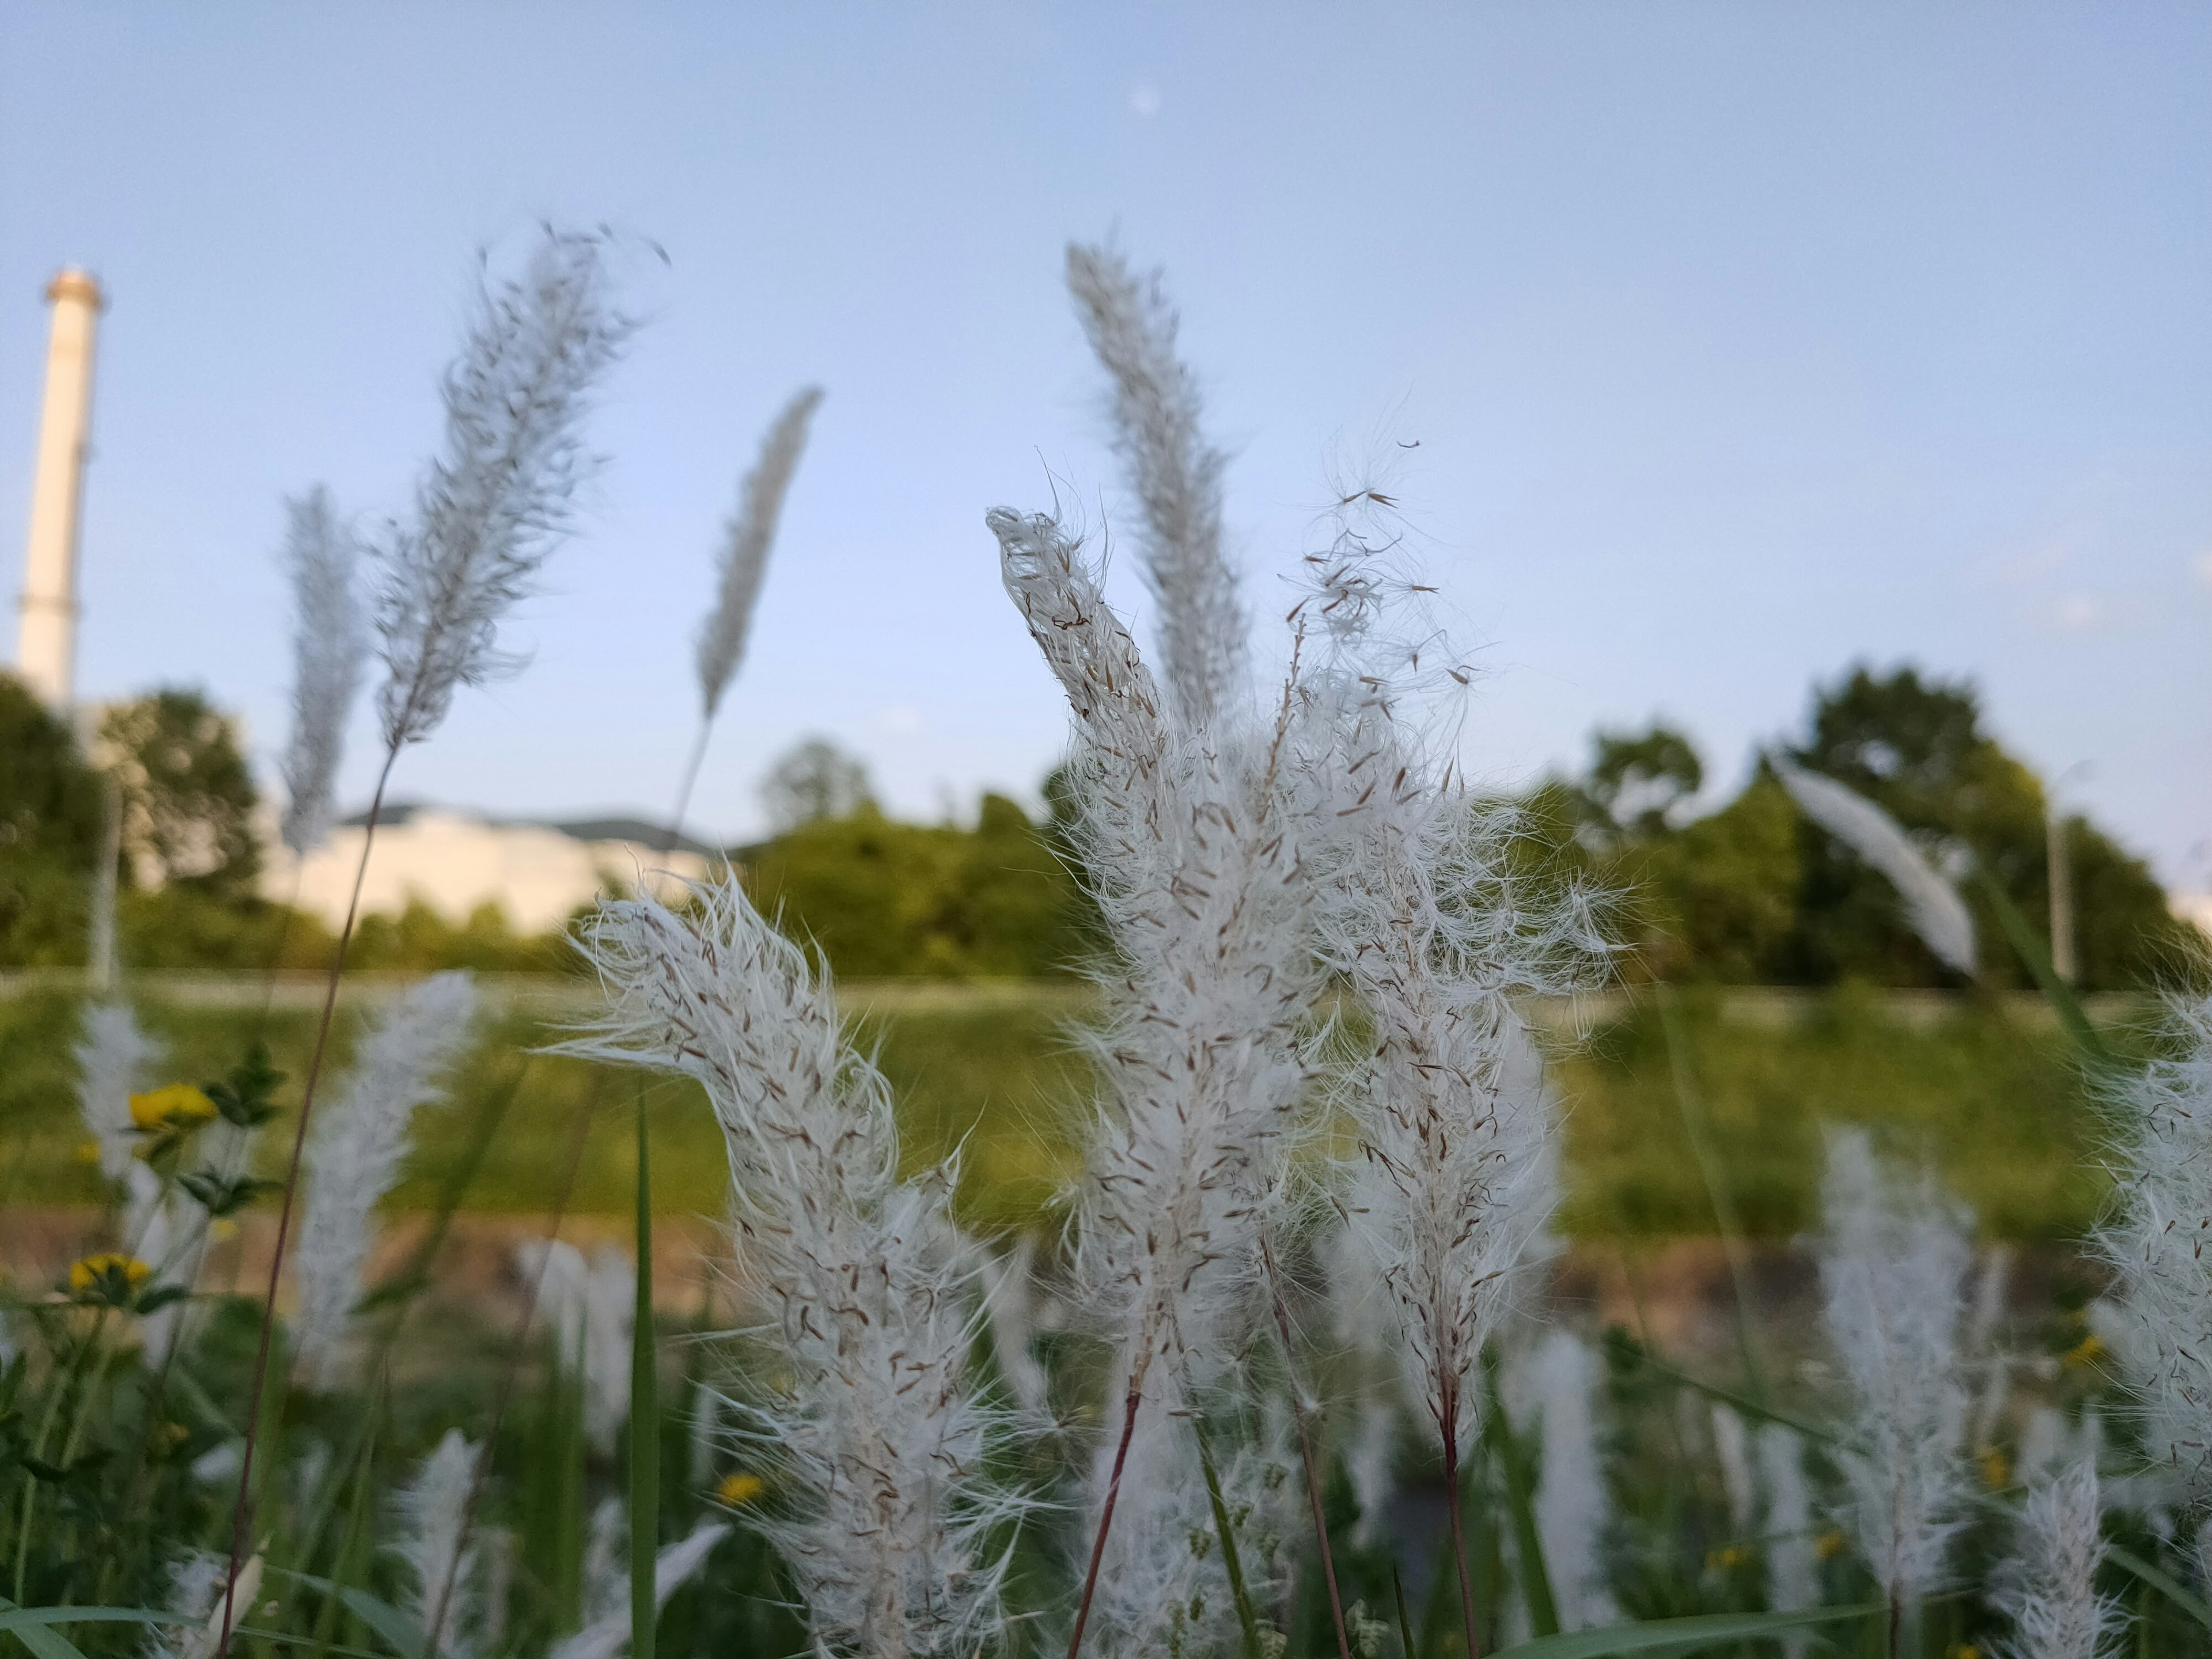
[{"xmin": 0, "ymin": 2, "xmax": 2212, "ymax": 889}]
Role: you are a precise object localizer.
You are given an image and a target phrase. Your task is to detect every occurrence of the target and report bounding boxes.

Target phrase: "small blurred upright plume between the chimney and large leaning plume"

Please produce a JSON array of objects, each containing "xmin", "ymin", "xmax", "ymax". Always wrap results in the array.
[{"xmin": 276, "ymin": 484, "xmax": 369, "ymax": 858}]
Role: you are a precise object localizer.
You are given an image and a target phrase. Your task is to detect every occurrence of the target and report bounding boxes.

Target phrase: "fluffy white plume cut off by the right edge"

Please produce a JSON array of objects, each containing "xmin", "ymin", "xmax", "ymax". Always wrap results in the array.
[{"xmin": 2097, "ymin": 998, "xmax": 2212, "ymax": 1500}]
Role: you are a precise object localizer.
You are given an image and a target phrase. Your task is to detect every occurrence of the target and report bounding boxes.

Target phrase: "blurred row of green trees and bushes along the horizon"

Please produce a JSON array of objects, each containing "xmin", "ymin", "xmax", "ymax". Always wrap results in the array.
[{"xmin": 0, "ymin": 666, "xmax": 2203, "ymax": 991}]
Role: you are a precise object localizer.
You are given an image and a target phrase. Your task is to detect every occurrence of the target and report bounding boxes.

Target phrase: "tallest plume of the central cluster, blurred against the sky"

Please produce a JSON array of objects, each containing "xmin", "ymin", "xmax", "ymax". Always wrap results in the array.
[{"xmin": 1069, "ymin": 243, "xmax": 1248, "ymax": 728}]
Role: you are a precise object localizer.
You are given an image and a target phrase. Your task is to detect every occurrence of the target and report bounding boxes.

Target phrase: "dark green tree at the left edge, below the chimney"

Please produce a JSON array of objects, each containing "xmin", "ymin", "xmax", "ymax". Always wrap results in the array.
[{"xmin": 0, "ymin": 675, "xmax": 104, "ymax": 967}]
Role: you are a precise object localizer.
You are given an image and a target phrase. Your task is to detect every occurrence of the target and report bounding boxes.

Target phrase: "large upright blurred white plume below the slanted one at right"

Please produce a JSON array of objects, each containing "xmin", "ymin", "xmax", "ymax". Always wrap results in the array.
[{"xmin": 1818, "ymin": 1130, "xmax": 1971, "ymax": 1606}]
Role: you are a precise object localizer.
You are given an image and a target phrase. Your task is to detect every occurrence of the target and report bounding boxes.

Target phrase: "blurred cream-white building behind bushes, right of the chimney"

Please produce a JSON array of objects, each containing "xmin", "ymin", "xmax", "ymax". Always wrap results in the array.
[{"xmin": 261, "ymin": 803, "xmax": 721, "ymax": 933}]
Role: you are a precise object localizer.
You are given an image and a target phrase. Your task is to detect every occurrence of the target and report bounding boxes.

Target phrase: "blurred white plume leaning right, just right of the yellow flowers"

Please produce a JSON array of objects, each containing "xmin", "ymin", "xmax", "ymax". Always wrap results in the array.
[{"xmin": 292, "ymin": 974, "xmax": 476, "ymax": 1389}]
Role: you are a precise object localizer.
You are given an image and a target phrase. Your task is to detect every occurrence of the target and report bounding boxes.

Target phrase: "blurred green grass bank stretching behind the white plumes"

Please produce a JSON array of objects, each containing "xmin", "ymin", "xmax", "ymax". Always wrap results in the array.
[{"xmin": 0, "ymin": 987, "xmax": 2141, "ymax": 1238}]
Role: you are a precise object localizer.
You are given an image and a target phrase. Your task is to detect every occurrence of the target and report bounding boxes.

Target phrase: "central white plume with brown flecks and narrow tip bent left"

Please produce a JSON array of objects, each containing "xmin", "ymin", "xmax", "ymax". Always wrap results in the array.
[{"xmin": 987, "ymin": 509, "xmax": 1316, "ymax": 1400}]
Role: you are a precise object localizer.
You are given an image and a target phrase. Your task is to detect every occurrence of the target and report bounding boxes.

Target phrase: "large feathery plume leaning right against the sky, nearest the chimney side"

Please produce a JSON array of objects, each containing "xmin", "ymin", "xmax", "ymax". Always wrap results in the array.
[{"xmin": 372, "ymin": 230, "xmax": 630, "ymax": 754}]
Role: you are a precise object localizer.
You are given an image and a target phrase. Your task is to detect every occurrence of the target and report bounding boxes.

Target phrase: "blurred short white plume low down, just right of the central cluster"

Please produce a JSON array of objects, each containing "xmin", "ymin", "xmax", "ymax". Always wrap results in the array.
[{"xmin": 1509, "ymin": 1330, "xmax": 1619, "ymax": 1630}]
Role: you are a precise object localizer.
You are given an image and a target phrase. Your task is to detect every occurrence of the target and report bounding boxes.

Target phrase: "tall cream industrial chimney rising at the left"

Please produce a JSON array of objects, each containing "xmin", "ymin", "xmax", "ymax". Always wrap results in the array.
[{"xmin": 16, "ymin": 270, "xmax": 104, "ymax": 717}]
